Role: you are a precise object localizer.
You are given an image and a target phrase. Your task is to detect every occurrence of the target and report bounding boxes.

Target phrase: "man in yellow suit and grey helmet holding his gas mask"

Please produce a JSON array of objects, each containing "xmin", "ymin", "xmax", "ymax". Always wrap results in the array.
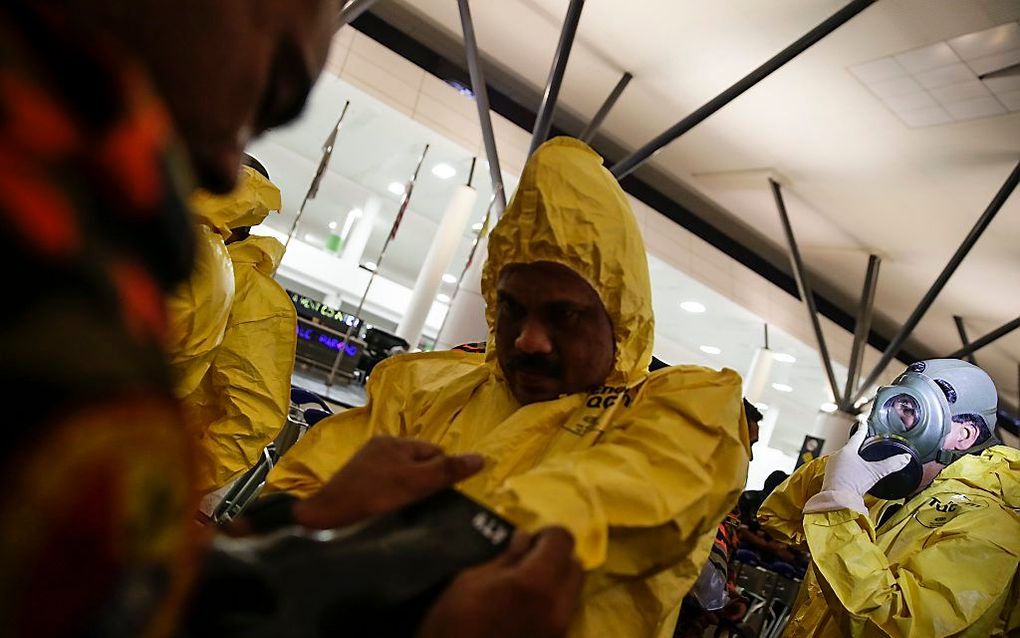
[{"xmin": 759, "ymin": 359, "xmax": 1020, "ymax": 638}]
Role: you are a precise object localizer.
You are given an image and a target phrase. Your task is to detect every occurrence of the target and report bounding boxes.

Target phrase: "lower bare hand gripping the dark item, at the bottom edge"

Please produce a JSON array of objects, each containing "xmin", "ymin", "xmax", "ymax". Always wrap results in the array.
[{"xmin": 418, "ymin": 528, "xmax": 581, "ymax": 638}]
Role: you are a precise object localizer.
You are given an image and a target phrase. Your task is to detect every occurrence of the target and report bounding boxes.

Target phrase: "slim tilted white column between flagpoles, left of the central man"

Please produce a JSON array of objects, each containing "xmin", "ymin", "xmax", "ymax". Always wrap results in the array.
[{"xmin": 397, "ymin": 186, "xmax": 478, "ymax": 348}]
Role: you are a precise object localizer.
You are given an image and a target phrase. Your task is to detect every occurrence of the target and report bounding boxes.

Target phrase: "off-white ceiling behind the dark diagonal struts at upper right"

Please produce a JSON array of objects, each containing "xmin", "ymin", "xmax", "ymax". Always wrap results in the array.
[{"xmin": 372, "ymin": 0, "xmax": 1020, "ymax": 406}]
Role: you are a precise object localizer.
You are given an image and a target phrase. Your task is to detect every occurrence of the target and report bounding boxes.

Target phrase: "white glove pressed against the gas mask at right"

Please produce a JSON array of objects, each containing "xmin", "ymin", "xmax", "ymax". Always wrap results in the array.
[{"xmin": 804, "ymin": 426, "xmax": 910, "ymax": 516}]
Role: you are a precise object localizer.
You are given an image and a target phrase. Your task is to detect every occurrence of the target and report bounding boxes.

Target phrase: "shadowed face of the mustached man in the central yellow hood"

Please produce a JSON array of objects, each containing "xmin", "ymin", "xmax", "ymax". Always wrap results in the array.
[{"xmin": 496, "ymin": 261, "xmax": 616, "ymax": 404}]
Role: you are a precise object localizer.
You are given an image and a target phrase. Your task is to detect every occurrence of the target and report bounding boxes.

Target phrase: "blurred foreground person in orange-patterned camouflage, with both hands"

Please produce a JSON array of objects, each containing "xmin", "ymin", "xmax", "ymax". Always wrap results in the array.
[{"xmin": 0, "ymin": 0, "xmax": 576, "ymax": 638}]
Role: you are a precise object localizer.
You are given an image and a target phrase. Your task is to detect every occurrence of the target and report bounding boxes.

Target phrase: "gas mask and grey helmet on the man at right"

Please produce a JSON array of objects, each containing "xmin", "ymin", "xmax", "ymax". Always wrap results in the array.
[{"xmin": 860, "ymin": 359, "xmax": 999, "ymax": 500}]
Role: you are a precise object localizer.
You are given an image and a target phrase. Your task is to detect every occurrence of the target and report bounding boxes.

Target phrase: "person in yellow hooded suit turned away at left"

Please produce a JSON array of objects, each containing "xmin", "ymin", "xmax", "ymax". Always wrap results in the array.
[{"xmin": 163, "ymin": 161, "xmax": 297, "ymax": 492}]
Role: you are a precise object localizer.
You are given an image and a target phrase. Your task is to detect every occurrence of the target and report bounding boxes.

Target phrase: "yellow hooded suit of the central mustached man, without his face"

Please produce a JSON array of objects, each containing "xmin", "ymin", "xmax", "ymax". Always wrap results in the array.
[{"xmin": 269, "ymin": 138, "xmax": 749, "ymax": 637}]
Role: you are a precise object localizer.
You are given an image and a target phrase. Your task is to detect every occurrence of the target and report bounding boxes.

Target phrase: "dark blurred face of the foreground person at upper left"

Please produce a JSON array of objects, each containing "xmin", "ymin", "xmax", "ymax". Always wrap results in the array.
[{"xmin": 118, "ymin": 0, "xmax": 340, "ymax": 192}]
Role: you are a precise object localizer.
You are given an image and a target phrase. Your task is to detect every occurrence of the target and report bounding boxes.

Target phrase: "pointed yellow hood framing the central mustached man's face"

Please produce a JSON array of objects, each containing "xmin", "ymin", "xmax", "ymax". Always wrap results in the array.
[{"xmin": 481, "ymin": 138, "xmax": 654, "ymax": 384}]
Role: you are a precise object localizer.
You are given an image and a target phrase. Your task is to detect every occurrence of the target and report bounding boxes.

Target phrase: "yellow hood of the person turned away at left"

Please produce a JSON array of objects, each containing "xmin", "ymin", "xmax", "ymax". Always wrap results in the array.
[{"xmin": 191, "ymin": 166, "xmax": 281, "ymax": 239}]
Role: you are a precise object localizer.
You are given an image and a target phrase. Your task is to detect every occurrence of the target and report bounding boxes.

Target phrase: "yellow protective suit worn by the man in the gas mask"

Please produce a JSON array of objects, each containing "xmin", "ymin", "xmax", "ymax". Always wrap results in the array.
[{"xmin": 758, "ymin": 446, "xmax": 1020, "ymax": 638}]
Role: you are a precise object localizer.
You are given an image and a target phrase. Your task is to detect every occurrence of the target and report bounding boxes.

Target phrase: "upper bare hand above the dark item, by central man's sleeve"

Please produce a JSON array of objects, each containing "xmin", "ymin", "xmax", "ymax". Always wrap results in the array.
[{"xmin": 293, "ymin": 437, "xmax": 483, "ymax": 530}]
